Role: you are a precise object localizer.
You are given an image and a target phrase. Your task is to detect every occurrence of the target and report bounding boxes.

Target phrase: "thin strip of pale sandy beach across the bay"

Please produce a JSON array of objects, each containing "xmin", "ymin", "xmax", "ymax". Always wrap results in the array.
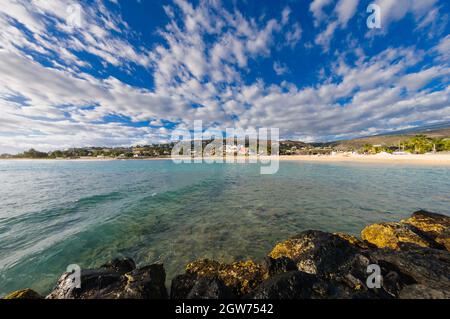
[{"xmin": 0, "ymin": 153, "xmax": 450, "ymax": 166}]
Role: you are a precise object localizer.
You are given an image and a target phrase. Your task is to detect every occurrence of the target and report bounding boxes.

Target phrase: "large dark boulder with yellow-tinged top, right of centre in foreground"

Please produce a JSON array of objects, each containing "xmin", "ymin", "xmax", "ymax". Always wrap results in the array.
[{"xmin": 270, "ymin": 231, "xmax": 414, "ymax": 298}]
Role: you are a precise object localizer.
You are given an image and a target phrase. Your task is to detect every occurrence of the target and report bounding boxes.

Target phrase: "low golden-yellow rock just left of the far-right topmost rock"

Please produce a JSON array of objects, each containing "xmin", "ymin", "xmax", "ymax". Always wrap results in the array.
[{"xmin": 361, "ymin": 222, "xmax": 437, "ymax": 250}]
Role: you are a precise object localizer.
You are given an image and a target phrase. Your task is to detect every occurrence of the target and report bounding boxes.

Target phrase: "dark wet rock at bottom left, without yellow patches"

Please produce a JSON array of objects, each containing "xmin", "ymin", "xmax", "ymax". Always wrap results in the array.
[{"xmin": 47, "ymin": 262, "xmax": 167, "ymax": 299}]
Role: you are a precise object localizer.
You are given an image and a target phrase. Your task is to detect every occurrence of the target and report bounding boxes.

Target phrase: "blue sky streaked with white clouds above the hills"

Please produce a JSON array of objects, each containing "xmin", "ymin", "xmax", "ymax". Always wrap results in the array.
[{"xmin": 0, "ymin": 0, "xmax": 450, "ymax": 152}]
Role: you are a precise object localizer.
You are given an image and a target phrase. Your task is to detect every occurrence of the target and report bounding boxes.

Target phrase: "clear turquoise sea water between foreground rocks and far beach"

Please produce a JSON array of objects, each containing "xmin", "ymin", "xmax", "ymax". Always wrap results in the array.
[{"xmin": 0, "ymin": 161, "xmax": 450, "ymax": 295}]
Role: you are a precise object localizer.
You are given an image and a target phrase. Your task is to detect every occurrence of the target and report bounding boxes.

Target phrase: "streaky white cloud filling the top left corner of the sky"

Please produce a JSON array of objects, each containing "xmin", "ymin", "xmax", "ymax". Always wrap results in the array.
[{"xmin": 0, "ymin": 0, "xmax": 150, "ymax": 67}]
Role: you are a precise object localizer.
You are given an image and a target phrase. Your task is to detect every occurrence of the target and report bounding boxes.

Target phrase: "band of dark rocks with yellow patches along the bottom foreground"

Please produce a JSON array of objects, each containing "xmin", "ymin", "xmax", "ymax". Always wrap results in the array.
[{"xmin": 5, "ymin": 211, "xmax": 450, "ymax": 299}]
